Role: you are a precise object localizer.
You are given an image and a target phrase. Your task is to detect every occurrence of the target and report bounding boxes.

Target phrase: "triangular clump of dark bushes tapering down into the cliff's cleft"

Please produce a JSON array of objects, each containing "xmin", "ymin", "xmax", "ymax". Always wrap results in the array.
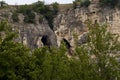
[{"xmin": 32, "ymin": 1, "xmax": 59, "ymax": 30}]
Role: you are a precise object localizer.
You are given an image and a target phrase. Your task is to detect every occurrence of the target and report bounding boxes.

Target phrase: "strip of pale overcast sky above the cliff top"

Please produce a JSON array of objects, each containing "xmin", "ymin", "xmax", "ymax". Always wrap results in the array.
[{"xmin": 0, "ymin": 0, "xmax": 74, "ymax": 4}]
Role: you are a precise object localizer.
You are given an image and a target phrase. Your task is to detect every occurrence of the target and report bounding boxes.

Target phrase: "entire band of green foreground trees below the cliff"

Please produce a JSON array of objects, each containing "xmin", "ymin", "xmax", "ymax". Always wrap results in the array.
[{"xmin": 0, "ymin": 21, "xmax": 120, "ymax": 80}]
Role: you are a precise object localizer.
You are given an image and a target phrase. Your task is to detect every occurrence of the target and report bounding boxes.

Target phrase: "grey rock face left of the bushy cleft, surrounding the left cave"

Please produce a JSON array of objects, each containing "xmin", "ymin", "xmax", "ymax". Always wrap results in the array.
[{"xmin": 0, "ymin": 8, "xmax": 57, "ymax": 49}]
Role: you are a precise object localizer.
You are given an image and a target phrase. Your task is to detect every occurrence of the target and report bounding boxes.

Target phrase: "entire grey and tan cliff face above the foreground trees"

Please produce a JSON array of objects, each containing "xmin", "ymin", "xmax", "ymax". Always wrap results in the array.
[{"xmin": 0, "ymin": 0, "xmax": 120, "ymax": 49}]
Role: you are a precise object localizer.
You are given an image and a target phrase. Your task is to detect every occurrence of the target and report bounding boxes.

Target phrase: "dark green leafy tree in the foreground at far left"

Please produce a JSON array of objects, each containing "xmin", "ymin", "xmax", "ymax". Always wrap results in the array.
[{"xmin": 0, "ymin": 21, "xmax": 28, "ymax": 80}]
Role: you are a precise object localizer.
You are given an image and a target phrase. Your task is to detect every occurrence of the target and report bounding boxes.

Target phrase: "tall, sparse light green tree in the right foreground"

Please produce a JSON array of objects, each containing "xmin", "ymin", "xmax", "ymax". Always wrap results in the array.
[{"xmin": 82, "ymin": 23, "xmax": 120, "ymax": 80}]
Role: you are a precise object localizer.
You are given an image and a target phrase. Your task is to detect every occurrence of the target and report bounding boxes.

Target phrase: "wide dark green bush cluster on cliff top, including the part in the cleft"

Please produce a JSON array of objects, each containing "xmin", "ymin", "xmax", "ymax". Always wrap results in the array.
[{"xmin": 17, "ymin": 1, "xmax": 59, "ymax": 29}]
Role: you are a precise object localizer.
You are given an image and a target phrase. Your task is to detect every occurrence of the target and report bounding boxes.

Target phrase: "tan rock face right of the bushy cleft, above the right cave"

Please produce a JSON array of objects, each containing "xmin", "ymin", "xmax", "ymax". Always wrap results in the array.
[{"xmin": 54, "ymin": 0, "xmax": 120, "ymax": 46}]
